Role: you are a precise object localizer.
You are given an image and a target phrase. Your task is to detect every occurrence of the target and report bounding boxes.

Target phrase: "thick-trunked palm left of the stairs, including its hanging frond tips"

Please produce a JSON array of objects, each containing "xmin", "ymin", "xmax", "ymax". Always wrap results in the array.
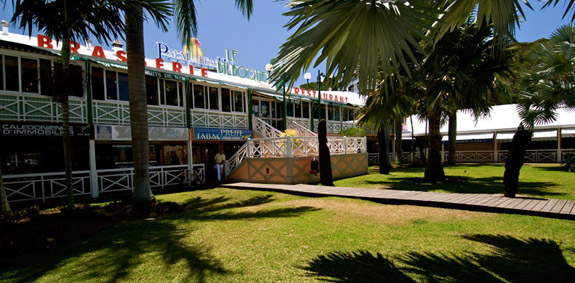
[{"xmin": 125, "ymin": 0, "xmax": 253, "ymax": 202}]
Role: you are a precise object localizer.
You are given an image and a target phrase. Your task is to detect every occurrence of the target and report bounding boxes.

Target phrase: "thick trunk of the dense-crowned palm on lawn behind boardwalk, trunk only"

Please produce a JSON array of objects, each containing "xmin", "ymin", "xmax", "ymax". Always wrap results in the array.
[{"xmin": 425, "ymin": 109, "xmax": 445, "ymax": 182}]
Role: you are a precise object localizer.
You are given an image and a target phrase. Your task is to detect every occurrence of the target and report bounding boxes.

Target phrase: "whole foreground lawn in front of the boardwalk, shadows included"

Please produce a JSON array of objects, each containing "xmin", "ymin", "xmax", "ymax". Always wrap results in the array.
[{"xmin": 0, "ymin": 188, "xmax": 575, "ymax": 282}]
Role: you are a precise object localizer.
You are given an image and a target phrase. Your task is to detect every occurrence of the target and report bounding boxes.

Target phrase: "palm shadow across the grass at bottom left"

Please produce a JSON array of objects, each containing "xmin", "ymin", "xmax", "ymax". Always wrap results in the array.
[{"xmin": 0, "ymin": 195, "xmax": 317, "ymax": 282}]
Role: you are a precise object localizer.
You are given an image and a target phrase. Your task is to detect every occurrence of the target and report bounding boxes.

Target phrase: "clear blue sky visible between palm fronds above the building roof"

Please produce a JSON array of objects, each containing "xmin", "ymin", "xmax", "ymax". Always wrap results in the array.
[{"xmin": 0, "ymin": 0, "xmax": 571, "ymax": 85}]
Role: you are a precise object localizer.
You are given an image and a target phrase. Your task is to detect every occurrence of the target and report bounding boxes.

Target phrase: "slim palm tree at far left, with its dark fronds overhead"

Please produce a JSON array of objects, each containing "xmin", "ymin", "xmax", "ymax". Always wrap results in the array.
[{"xmin": 12, "ymin": 0, "xmax": 132, "ymax": 209}]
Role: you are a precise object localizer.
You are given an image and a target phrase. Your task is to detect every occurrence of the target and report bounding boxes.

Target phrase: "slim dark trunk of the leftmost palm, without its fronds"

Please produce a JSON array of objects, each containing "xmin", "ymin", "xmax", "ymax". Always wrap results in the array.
[{"xmin": 58, "ymin": 33, "xmax": 74, "ymax": 209}]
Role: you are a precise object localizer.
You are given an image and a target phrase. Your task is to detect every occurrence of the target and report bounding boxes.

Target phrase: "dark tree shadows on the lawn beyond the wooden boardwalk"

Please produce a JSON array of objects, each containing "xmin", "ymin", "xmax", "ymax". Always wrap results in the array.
[{"xmin": 366, "ymin": 176, "xmax": 567, "ymax": 197}]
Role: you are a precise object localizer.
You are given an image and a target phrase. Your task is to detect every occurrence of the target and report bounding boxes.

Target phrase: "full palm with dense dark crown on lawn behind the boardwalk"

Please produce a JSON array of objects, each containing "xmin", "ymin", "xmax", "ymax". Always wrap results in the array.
[{"xmin": 421, "ymin": 22, "xmax": 511, "ymax": 181}]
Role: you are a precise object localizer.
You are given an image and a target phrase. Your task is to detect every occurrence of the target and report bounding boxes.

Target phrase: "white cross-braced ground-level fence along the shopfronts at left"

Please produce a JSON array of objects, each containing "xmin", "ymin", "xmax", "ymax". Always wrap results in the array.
[{"xmin": 0, "ymin": 164, "xmax": 206, "ymax": 202}]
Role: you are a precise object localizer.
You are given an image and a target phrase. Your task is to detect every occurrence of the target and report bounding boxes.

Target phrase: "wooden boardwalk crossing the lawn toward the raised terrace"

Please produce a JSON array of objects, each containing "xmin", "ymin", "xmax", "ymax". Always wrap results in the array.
[{"xmin": 222, "ymin": 183, "xmax": 575, "ymax": 220}]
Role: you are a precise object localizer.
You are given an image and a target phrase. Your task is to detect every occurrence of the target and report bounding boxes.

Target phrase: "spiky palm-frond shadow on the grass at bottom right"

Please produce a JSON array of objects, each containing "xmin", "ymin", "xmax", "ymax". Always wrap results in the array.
[{"xmin": 302, "ymin": 235, "xmax": 575, "ymax": 282}]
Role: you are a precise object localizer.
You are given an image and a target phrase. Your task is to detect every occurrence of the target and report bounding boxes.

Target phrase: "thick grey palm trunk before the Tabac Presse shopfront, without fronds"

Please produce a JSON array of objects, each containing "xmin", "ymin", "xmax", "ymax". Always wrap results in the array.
[{"xmin": 126, "ymin": 5, "xmax": 154, "ymax": 202}]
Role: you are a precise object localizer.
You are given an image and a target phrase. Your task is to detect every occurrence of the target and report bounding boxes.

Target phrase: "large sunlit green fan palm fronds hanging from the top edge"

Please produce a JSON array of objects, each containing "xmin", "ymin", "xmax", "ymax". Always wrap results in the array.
[{"xmin": 272, "ymin": 0, "xmax": 544, "ymax": 93}]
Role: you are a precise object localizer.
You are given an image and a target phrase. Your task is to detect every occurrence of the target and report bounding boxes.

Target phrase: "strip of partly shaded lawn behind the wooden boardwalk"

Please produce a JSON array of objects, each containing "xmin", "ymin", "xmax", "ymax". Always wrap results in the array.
[{"xmin": 334, "ymin": 164, "xmax": 575, "ymax": 200}]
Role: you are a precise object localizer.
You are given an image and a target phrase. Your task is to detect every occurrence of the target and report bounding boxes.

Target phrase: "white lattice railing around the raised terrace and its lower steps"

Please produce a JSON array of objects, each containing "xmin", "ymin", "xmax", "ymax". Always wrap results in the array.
[{"xmin": 226, "ymin": 136, "xmax": 367, "ymax": 175}]
